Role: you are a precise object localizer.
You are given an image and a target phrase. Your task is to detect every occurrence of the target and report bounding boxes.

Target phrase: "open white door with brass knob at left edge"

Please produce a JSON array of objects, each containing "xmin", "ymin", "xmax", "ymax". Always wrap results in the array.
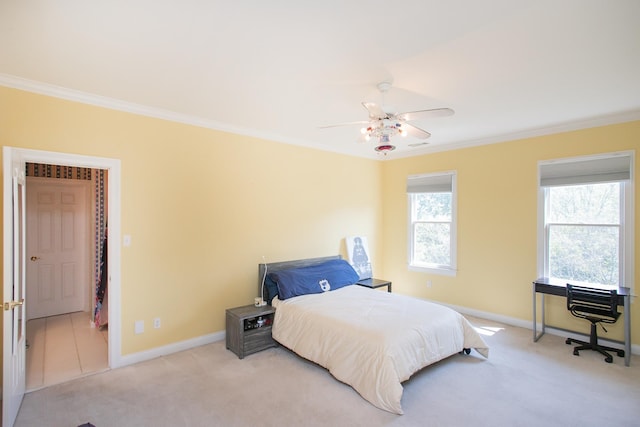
[{"xmin": 2, "ymin": 147, "xmax": 26, "ymax": 427}]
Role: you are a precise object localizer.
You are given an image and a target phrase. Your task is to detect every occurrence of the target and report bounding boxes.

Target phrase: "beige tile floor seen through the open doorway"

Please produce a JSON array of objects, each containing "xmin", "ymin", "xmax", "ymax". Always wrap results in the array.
[{"xmin": 26, "ymin": 312, "xmax": 109, "ymax": 391}]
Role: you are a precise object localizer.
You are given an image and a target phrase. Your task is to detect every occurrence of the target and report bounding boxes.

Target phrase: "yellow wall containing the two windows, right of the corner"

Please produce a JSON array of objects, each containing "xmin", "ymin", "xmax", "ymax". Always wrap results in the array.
[{"xmin": 382, "ymin": 121, "xmax": 640, "ymax": 344}]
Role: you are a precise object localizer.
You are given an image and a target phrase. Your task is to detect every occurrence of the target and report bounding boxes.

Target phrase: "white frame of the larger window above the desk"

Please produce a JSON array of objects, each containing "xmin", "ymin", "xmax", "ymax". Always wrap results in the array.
[{"xmin": 537, "ymin": 151, "xmax": 635, "ymax": 291}]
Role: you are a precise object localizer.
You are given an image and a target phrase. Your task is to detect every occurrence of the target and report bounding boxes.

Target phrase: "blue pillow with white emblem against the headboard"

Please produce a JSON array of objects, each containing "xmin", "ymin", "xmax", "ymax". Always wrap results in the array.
[{"xmin": 267, "ymin": 259, "xmax": 360, "ymax": 300}]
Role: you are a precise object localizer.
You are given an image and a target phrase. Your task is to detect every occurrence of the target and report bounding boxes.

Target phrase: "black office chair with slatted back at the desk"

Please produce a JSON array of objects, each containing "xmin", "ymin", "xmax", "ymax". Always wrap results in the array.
[{"xmin": 565, "ymin": 284, "xmax": 624, "ymax": 363}]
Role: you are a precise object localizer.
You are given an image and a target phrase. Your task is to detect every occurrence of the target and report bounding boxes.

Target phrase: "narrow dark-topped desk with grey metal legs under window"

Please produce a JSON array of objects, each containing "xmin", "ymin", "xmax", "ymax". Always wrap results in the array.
[{"xmin": 533, "ymin": 277, "xmax": 631, "ymax": 366}]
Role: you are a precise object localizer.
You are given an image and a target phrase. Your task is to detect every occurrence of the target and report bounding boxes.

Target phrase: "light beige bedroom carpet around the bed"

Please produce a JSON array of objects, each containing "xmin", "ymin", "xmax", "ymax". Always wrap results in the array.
[{"xmin": 11, "ymin": 317, "xmax": 640, "ymax": 427}]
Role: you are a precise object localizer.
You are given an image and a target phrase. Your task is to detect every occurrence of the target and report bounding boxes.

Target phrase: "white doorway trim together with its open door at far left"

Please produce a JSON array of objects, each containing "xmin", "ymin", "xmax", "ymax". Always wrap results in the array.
[{"xmin": 2, "ymin": 146, "xmax": 124, "ymax": 426}]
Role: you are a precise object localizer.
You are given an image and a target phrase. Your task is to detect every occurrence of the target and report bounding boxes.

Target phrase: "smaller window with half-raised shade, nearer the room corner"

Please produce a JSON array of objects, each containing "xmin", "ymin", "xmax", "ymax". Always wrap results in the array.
[{"xmin": 407, "ymin": 172, "xmax": 456, "ymax": 276}]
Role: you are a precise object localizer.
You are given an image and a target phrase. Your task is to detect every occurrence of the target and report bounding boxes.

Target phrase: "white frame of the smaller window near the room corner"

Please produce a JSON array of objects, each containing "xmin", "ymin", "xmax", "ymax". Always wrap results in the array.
[{"xmin": 407, "ymin": 171, "xmax": 458, "ymax": 276}]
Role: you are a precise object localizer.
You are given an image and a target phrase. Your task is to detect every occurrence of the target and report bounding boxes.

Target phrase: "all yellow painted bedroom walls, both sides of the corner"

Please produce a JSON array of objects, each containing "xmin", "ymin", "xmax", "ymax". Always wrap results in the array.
[{"xmin": 0, "ymin": 83, "xmax": 640, "ymax": 384}]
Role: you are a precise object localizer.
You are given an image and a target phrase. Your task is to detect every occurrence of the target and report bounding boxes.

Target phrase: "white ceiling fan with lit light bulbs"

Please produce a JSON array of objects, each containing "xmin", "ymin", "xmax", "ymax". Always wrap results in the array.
[{"xmin": 321, "ymin": 82, "xmax": 454, "ymax": 154}]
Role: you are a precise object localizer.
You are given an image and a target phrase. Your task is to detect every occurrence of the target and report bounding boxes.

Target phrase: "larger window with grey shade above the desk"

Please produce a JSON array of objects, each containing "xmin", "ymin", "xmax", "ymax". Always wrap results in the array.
[{"xmin": 538, "ymin": 153, "xmax": 634, "ymax": 286}]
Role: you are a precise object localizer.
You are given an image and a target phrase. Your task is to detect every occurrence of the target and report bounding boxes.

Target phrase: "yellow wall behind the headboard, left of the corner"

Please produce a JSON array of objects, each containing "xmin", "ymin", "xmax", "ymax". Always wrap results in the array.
[{"xmin": 0, "ymin": 87, "xmax": 382, "ymax": 355}]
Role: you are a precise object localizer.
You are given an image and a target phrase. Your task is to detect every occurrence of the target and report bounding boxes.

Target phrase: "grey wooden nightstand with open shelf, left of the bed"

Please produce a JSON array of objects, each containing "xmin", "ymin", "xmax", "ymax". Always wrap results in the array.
[{"xmin": 226, "ymin": 305, "xmax": 276, "ymax": 359}]
